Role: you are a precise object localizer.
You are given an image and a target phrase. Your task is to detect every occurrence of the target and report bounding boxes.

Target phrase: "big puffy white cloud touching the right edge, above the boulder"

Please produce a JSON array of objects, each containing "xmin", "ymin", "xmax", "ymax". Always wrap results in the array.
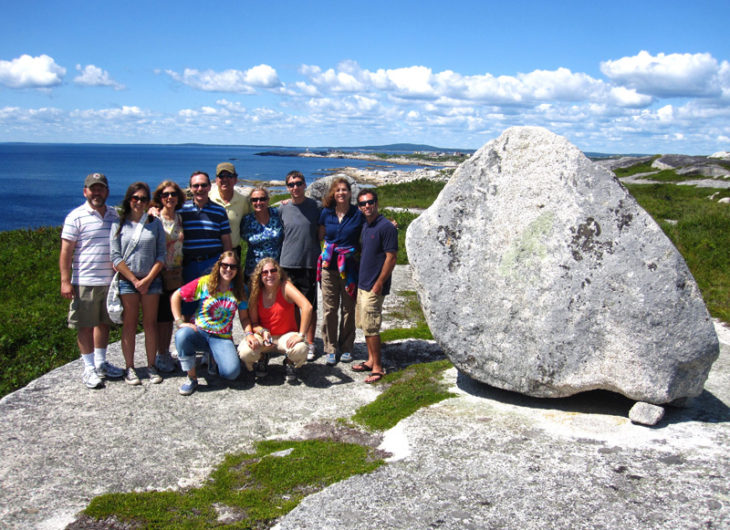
[{"xmin": 601, "ymin": 50, "xmax": 729, "ymax": 97}]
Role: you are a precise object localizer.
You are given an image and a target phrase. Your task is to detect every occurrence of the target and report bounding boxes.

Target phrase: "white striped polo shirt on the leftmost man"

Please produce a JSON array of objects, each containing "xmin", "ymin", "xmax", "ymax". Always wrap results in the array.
[{"xmin": 61, "ymin": 202, "xmax": 119, "ymax": 286}]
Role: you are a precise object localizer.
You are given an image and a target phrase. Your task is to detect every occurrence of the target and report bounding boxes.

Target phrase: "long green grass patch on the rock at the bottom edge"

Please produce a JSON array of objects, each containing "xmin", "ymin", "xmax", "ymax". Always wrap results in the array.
[{"xmin": 83, "ymin": 440, "xmax": 384, "ymax": 529}]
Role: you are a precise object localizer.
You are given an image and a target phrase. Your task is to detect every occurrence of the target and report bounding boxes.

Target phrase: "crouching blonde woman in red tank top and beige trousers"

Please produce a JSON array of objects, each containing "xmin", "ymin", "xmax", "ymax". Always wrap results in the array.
[{"xmin": 238, "ymin": 258, "xmax": 312, "ymax": 383}]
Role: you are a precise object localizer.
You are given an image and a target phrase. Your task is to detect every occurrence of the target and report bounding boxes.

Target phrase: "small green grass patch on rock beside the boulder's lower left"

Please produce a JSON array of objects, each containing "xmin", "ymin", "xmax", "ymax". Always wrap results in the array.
[{"xmin": 352, "ymin": 360, "xmax": 455, "ymax": 430}]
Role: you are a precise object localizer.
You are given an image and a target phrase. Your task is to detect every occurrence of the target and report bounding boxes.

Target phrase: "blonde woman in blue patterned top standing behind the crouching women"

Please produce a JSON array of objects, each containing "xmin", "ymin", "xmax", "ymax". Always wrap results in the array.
[{"xmin": 241, "ymin": 187, "xmax": 284, "ymax": 278}]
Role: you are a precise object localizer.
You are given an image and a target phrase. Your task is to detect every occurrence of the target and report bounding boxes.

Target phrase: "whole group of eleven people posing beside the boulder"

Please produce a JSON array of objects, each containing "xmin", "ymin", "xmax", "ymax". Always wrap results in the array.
[{"xmin": 59, "ymin": 162, "xmax": 398, "ymax": 395}]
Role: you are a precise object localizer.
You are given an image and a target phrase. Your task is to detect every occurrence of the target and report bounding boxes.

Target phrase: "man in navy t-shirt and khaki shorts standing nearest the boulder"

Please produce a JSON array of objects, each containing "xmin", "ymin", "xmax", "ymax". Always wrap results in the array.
[{"xmin": 352, "ymin": 189, "xmax": 398, "ymax": 383}]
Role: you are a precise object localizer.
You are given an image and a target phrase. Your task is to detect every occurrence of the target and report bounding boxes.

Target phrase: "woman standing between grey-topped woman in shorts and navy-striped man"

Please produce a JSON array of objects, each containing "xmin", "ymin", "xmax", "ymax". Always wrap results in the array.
[{"xmin": 150, "ymin": 180, "xmax": 185, "ymax": 372}]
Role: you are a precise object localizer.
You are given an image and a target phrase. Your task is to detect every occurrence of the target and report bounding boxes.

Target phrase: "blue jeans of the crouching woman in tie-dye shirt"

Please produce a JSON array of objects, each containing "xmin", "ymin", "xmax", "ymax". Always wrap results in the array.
[{"xmin": 175, "ymin": 326, "xmax": 241, "ymax": 380}]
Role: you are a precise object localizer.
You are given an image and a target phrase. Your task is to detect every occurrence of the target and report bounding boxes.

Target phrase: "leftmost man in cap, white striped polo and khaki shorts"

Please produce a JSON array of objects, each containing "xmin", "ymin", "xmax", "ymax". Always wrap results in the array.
[{"xmin": 59, "ymin": 173, "xmax": 124, "ymax": 388}]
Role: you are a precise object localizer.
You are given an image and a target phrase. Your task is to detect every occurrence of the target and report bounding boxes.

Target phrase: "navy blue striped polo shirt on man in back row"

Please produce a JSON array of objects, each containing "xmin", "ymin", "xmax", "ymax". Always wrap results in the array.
[{"xmin": 178, "ymin": 200, "xmax": 231, "ymax": 259}]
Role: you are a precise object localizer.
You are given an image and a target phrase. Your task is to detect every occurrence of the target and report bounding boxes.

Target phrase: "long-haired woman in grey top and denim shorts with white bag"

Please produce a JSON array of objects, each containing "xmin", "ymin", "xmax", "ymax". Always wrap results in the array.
[{"xmin": 109, "ymin": 182, "xmax": 166, "ymax": 385}]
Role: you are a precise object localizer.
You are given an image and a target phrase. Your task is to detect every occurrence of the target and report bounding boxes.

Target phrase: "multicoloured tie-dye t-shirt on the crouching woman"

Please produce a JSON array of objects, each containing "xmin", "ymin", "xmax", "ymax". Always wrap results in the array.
[{"xmin": 180, "ymin": 275, "xmax": 248, "ymax": 339}]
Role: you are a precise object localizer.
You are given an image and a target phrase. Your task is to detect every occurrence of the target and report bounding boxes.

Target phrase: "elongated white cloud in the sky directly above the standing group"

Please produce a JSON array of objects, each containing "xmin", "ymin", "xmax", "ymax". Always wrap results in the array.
[{"xmin": 165, "ymin": 64, "xmax": 282, "ymax": 94}]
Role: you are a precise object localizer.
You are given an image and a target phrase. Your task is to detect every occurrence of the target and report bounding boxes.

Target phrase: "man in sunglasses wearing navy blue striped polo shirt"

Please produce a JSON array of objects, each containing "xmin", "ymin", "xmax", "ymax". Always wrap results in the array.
[{"xmin": 178, "ymin": 171, "xmax": 231, "ymax": 318}]
